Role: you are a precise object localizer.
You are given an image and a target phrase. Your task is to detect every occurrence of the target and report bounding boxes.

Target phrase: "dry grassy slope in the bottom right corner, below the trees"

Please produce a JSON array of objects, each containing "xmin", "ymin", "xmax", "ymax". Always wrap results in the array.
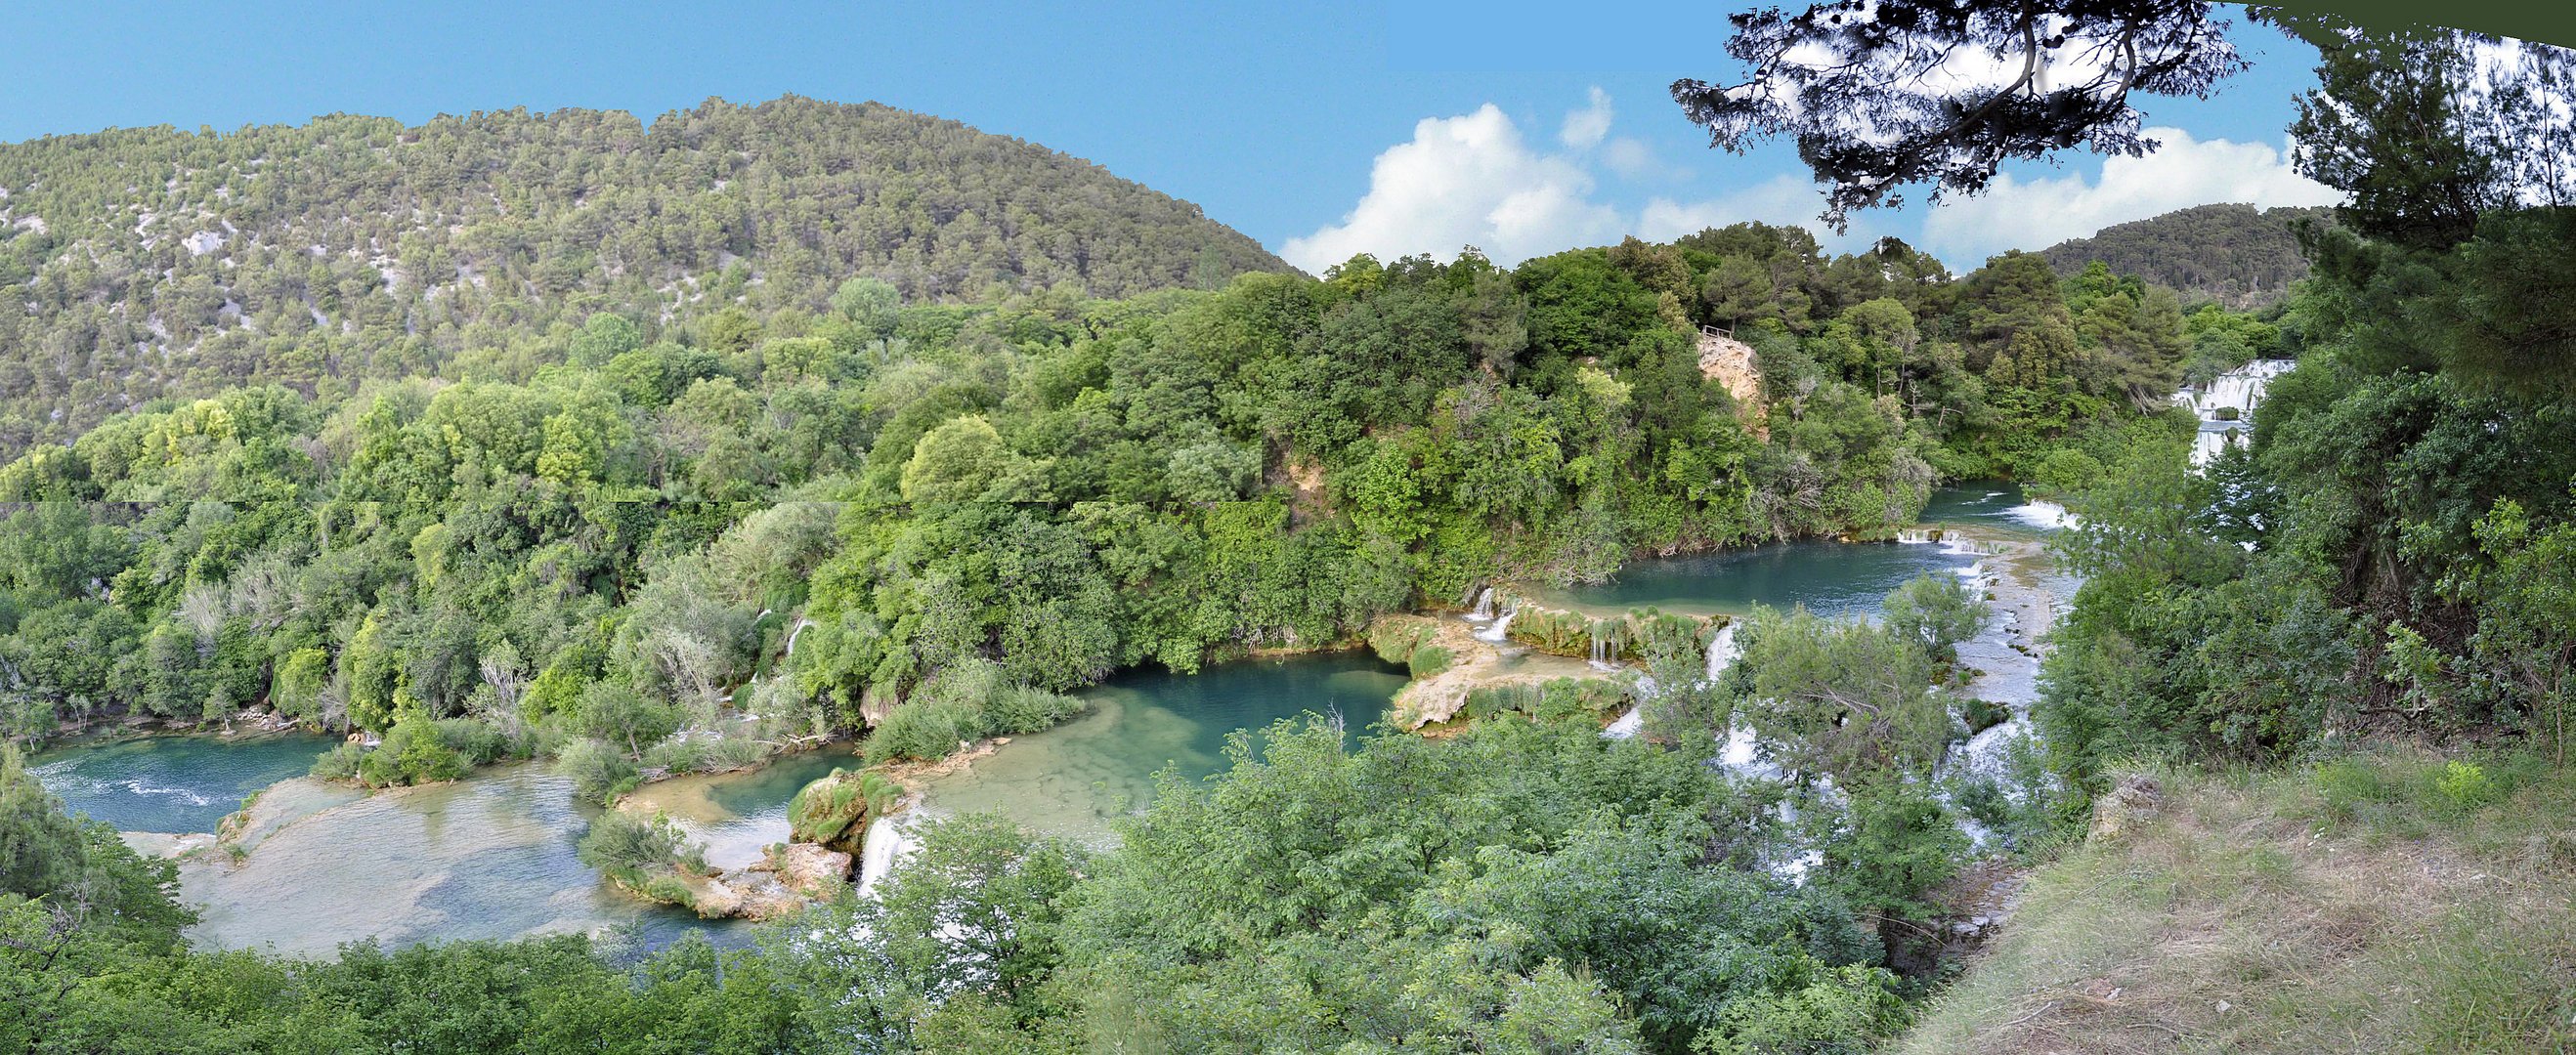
[{"xmin": 1891, "ymin": 751, "xmax": 2576, "ymax": 1052}]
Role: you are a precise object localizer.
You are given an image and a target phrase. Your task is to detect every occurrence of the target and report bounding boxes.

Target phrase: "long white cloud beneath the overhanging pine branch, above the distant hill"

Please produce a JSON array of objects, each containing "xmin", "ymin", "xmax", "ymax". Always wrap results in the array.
[{"xmin": 1921, "ymin": 129, "xmax": 2341, "ymax": 268}]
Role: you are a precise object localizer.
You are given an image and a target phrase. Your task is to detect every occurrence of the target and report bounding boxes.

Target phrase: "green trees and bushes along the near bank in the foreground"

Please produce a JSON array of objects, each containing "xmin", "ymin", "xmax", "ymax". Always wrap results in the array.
[{"xmin": 0, "ymin": 721, "xmax": 1911, "ymax": 1052}]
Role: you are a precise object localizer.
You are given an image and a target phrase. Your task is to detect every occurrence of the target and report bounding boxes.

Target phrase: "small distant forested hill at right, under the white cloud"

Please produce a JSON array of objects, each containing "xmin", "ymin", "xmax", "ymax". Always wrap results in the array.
[{"xmin": 2040, "ymin": 203, "xmax": 2334, "ymax": 309}]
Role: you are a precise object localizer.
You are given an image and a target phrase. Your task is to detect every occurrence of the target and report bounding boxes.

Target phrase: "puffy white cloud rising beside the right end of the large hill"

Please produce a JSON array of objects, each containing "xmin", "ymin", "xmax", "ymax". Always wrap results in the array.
[{"xmin": 1280, "ymin": 103, "xmax": 1628, "ymax": 273}]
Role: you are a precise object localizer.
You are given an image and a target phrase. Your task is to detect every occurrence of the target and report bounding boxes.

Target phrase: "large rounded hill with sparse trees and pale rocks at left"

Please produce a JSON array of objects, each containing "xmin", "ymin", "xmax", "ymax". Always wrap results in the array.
[{"xmin": 0, "ymin": 95, "xmax": 1288, "ymax": 453}]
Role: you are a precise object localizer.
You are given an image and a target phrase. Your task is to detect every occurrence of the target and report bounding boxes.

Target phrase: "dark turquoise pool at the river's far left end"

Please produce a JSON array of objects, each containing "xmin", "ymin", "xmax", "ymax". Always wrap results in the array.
[{"xmin": 28, "ymin": 734, "xmax": 337, "ymax": 833}]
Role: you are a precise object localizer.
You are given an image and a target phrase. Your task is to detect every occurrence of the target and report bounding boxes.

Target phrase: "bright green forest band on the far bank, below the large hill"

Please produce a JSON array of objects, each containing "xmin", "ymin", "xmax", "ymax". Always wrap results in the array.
[{"xmin": 0, "ymin": 148, "xmax": 2214, "ymax": 800}]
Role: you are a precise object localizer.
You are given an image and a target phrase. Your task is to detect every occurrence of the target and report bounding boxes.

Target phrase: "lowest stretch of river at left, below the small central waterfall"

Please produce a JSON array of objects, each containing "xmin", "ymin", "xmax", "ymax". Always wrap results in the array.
[{"xmin": 31, "ymin": 734, "xmax": 855, "ymax": 954}]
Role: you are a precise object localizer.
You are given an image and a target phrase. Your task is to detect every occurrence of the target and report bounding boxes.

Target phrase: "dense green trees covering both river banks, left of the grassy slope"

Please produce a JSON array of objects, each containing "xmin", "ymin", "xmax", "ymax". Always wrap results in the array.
[{"xmin": 0, "ymin": 150, "xmax": 2214, "ymax": 1050}]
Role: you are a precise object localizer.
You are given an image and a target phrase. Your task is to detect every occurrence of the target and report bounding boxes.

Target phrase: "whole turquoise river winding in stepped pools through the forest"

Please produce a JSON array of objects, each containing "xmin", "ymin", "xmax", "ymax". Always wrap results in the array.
[{"xmin": 33, "ymin": 484, "xmax": 2071, "ymax": 954}]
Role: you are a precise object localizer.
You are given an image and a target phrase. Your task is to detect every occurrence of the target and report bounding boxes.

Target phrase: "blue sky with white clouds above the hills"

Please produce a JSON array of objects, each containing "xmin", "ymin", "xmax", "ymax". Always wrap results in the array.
[{"xmin": 0, "ymin": 0, "xmax": 2326, "ymax": 268}]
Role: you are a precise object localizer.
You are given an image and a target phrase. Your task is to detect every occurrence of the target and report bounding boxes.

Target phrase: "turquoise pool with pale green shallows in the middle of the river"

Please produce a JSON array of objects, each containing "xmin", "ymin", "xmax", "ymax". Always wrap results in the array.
[{"xmin": 920, "ymin": 651, "xmax": 1406, "ymax": 841}]
